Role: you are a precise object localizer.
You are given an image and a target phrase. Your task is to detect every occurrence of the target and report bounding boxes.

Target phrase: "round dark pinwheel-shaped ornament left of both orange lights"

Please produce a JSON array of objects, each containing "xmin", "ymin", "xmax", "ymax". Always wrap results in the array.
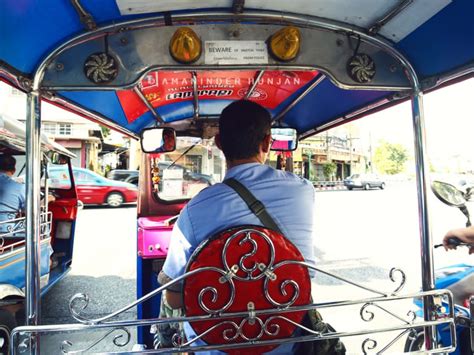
[{"xmin": 84, "ymin": 53, "xmax": 118, "ymax": 84}]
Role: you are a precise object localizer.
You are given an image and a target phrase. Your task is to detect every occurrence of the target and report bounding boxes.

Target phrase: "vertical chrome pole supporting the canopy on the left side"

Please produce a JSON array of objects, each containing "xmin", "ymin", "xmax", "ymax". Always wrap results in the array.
[{"xmin": 25, "ymin": 90, "xmax": 41, "ymax": 354}]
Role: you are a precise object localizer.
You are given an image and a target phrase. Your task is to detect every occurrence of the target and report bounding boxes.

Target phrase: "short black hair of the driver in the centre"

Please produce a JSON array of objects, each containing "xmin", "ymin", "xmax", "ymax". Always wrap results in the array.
[{"xmin": 219, "ymin": 100, "xmax": 272, "ymax": 160}]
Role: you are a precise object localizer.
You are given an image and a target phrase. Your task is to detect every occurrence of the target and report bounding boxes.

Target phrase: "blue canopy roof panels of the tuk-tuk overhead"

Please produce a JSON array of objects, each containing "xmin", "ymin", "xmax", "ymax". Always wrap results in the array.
[{"xmin": 0, "ymin": 0, "xmax": 474, "ymax": 138}]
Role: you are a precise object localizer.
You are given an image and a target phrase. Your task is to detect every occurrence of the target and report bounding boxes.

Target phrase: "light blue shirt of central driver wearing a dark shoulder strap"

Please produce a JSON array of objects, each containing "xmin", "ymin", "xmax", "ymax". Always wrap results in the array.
[{"xmin": 163, "ymin": 163, "xmax": 315, "ymax": 354}]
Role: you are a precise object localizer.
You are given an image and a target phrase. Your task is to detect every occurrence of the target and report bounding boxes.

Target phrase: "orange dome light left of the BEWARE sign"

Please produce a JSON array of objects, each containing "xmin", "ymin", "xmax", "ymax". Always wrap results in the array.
[{"xmin": 170, "ymin": 27, "xmax": 202, "ymax": 64}]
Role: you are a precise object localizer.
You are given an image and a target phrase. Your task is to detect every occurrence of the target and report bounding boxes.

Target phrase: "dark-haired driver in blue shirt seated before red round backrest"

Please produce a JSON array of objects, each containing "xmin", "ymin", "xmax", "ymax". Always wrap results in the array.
[{"xmin": 159, "ymin": 100, "xmax": 315, "ymax": 354}]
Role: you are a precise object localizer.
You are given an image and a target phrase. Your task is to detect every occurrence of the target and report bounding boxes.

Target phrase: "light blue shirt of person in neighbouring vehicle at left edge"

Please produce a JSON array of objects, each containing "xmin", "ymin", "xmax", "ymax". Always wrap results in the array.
[{"xmin": 0, "ymin": 173, "xmax": 26, "ymax": 232}]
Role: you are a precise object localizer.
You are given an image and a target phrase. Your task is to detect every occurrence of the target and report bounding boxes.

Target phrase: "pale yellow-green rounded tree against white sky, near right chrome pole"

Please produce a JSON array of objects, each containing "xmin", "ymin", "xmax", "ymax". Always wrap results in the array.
[{"xmin": 374, "ymin": 141, "xmax": 408, "ymax": 175}]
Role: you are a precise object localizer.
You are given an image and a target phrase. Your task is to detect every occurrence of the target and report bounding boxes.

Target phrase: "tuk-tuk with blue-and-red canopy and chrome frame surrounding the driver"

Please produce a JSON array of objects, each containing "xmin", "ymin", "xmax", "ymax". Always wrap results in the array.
[{"xmin": 0, "ymin": 0, "xmax": 474, "ymax": 352}]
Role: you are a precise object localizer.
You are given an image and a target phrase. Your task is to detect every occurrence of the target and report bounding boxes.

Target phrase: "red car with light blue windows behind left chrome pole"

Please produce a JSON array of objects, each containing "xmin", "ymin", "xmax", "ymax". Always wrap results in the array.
[{"xmin": 49, "ymin": 167, "xmax": 138, "ymax": 207}]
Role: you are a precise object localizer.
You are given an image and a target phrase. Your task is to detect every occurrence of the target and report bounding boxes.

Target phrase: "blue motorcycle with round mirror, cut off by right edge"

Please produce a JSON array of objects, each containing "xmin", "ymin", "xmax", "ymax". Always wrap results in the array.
[{"xmin": 405, "ymin": 181, "xmax": 474, "ymax": 355}]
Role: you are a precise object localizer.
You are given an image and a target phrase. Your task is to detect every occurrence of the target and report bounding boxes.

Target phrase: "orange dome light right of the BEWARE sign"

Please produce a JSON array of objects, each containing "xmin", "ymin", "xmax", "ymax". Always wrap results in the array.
[{"xmin": 270, "ymin": 26, "xmax": 301, "ymax": 62}]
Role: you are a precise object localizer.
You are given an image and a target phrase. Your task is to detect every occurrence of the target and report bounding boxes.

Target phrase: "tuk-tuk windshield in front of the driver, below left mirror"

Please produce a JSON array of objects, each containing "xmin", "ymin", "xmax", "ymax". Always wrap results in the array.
[{"xmin": 150, "ymin": 137, "xmax": 225, "ymax": 201}]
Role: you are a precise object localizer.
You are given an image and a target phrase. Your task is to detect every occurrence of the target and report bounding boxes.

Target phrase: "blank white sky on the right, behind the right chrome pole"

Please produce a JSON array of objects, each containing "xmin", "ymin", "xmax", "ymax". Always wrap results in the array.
[{"xmin": 353, "ymin": 79, "xmax": 474, "ymax": 170}]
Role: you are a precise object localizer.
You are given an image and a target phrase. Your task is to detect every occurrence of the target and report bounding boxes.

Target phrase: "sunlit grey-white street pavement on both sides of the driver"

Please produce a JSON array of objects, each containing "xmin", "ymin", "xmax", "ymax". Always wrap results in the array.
[{"xmin": 42, "ymin": 183, "xmax": 473, "ymax": 354}]
